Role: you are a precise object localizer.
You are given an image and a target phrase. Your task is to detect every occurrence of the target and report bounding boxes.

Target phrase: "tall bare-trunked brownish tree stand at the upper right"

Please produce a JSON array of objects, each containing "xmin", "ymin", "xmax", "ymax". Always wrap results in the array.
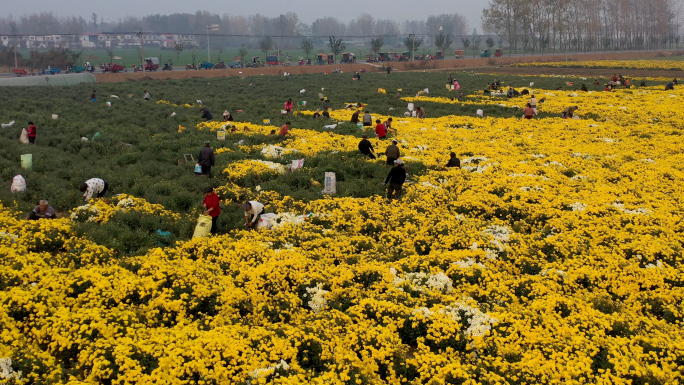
[{"xmin": 482, "ymin": 0, "xmax": 681, "ymax": 52}]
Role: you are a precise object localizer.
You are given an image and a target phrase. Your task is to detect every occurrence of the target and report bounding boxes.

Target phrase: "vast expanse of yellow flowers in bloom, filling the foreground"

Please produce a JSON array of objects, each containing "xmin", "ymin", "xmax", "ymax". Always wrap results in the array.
[{"xmin": 0, "ymin": 73, "xmax": 684, "ymax": 385}]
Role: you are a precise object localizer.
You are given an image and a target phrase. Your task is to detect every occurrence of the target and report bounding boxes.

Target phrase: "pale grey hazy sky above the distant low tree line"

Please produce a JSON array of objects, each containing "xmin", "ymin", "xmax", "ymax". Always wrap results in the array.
[{"xmin": 2, "ymin": 0, "xmax": 488, "ymax": 30}]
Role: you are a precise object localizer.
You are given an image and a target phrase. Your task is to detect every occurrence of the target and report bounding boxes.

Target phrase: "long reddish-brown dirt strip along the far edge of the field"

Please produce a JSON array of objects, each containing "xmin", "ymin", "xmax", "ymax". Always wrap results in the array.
[{"xmin": 95, "ymin": 51, "xmax": 684, "ymax": 83}]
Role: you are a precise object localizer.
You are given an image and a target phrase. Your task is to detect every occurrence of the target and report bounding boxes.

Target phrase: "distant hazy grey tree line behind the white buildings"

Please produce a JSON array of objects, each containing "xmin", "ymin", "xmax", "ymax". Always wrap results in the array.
[{"xmin": 0, "ymin": 11, "xmax": 469, "ymax": 48}]
